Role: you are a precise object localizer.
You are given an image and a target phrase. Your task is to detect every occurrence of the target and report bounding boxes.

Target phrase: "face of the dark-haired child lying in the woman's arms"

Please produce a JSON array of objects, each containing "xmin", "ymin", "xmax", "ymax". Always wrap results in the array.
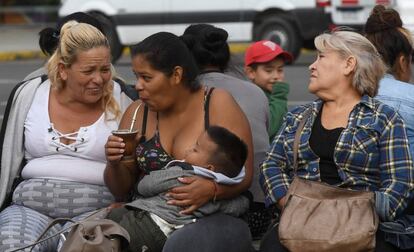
[{"xmin": 184, "ymin": 132, "xmax": 217, "ymax": 170}]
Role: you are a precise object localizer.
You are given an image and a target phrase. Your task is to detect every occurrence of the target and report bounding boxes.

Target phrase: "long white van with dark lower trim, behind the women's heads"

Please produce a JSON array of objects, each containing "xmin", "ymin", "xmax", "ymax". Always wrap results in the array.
[{"xmin": 59, "ymin": 0, "xmax": 330, "ymax": 60}]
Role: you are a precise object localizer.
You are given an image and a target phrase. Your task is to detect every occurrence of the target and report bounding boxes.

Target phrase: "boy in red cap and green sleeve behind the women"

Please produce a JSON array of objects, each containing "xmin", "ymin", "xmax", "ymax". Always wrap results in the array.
[{"xmin": 244, "ymin": 40, "xmax": 293, "ymax": 140}]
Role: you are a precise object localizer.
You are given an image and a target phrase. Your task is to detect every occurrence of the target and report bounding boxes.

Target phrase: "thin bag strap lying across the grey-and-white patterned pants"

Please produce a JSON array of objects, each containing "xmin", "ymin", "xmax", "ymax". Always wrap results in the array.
[{"xmin": 9, "ymin": 208, "xmax": 108, "ymax": 252}]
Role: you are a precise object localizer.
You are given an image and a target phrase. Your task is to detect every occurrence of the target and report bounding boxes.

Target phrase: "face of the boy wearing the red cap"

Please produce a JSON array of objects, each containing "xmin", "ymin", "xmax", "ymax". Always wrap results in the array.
[{"xmin": 246, "ymin": 57, "xmax": 285, "ymax": 92}]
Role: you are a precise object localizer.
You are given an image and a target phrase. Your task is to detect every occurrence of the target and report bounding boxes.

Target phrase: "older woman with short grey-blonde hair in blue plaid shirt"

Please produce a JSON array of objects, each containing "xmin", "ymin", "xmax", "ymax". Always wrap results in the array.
[{"xmin": 261, "ymin": 31, "xmax": 413, "ymax": 252}]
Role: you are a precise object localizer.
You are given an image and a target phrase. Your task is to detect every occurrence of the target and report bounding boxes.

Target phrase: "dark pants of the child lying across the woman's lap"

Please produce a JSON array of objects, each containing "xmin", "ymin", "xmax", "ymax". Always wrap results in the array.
[{"xmin": 107, "ymin": 207, "xmax": 167, "ymax": 252}]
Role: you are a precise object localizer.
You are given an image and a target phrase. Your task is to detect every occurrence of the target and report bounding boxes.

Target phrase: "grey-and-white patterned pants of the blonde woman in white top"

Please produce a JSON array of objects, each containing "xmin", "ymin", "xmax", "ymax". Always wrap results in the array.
[{"xmin": 0, "ymin": 179, "xmax": 113, "ymax": 251}]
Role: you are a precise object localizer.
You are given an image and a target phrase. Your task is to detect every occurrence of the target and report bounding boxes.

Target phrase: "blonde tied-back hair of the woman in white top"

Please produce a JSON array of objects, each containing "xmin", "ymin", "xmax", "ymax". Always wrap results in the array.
[{"xmin": 46, "ymin": 21, "xmax": 121, "ymax": 120}]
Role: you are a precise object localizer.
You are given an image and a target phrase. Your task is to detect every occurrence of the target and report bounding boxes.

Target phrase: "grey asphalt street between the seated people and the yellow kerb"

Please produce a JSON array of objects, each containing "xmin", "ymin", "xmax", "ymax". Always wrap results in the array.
[{"xmin": 0, "ymin": 52, "xmax": 316, "ymax": 125}]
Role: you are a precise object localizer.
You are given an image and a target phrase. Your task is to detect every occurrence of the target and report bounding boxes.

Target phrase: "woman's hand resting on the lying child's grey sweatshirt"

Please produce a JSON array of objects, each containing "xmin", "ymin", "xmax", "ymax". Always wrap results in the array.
[{"xmin": 167, "ymin": 176, "xmax": 216, "ymax": 214}]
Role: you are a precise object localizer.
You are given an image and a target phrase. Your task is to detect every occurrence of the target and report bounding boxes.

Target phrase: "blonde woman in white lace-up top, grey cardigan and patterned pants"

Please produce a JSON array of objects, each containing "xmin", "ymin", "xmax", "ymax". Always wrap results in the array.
[{"xmin": 0, "ymin": 21, "xmax": 131, "ymax": 251}]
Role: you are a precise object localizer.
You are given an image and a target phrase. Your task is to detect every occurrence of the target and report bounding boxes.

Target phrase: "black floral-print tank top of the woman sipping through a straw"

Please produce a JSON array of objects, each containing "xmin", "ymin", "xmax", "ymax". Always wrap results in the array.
[{"xmin": 136, "ymin": 88, "xmax": 214, "ymax": 174}]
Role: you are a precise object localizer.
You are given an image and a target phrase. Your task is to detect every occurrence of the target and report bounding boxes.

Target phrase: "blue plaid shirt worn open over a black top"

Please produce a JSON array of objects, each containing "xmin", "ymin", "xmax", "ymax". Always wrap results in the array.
[{"xmin": 260, "ymin": 96, "xmax": 414, "ymax": 219}]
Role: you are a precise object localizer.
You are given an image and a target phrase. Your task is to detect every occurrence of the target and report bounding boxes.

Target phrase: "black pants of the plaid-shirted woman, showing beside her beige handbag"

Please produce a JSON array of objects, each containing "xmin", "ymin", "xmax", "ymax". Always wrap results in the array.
[{"xmin": 260, "ymin": 221, "xmax": 402, "ymax": 252}]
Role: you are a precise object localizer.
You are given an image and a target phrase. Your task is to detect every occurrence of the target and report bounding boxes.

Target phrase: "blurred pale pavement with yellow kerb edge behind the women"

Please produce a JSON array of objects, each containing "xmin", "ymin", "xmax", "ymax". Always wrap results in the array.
[{"xmin": 0, "ymin": 24, "xmax": 252, "ymax": 62}]
